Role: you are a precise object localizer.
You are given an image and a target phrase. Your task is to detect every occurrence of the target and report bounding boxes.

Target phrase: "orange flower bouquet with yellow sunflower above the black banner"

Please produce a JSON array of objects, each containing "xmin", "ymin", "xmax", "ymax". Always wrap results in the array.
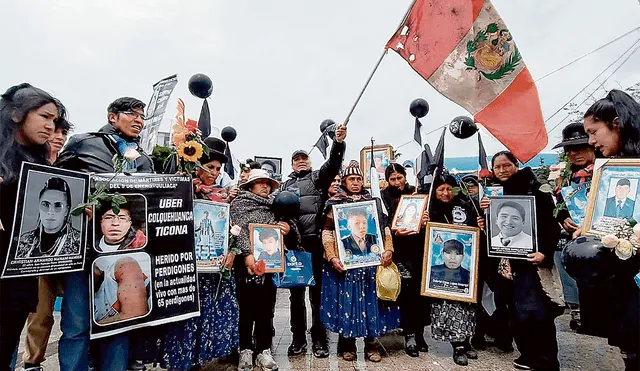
[{"xmin": 168, "ymin": 99, "xmax": 209, "ymax": 174}]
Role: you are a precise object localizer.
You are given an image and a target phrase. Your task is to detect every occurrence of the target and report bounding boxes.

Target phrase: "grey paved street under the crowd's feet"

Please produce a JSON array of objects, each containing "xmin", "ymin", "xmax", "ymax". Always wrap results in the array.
[{"xmin": 18, "ymin": 290, "xmax": 624, "ymax": 371}]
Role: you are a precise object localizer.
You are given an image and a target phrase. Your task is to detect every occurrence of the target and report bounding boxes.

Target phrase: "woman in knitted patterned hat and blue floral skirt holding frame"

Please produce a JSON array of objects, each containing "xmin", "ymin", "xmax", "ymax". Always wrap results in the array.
[{"xmin": 320, "ymin": 161, "xmax": 399, "ymax": 362}]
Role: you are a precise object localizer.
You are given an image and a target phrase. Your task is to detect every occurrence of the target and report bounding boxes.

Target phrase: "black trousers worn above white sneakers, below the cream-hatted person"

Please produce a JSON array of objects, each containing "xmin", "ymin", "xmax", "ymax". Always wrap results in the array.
[{"xmin": 236, "ymin": 274, "xmax": 276, "ymax": 352}]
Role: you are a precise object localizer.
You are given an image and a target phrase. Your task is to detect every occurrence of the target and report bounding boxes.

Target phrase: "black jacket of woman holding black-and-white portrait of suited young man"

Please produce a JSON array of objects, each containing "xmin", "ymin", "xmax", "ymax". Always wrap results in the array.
[{"xmin": 501, "ymin": 167, "xmax": 560, "ymax": 271}]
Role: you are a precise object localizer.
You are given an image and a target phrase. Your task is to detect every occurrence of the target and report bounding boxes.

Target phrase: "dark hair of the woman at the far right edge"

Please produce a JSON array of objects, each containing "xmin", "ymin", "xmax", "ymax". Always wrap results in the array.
[{"xmin": 584, "ymin": 89, "xmax": 640, "ymax": 157}]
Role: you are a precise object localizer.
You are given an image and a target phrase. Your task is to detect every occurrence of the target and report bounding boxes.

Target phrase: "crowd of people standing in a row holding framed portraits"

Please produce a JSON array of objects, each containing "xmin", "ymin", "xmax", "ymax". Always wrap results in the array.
[{"xmin": 0, "ymin": 83, "xmax": 640, "ymax": 371}]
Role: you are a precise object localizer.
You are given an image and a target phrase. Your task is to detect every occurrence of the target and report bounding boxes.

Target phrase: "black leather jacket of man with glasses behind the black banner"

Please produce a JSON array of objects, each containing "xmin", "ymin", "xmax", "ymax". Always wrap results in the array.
[{"xmin": 55, "ymin": 124, "xmax": 154, "ymax": 173}]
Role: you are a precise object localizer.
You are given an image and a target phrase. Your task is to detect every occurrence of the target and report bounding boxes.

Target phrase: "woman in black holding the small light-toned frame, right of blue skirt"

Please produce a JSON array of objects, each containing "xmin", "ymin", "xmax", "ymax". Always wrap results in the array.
[{"xmin": 382, "ymin": 163, "xmax": 431, "ymax": 357}]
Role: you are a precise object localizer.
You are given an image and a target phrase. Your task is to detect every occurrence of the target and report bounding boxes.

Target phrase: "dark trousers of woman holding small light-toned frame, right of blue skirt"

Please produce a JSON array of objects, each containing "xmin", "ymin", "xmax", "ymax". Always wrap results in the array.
[{"xmin": 396, "ymin": 276, "xmax": 431, "ymax": 336}]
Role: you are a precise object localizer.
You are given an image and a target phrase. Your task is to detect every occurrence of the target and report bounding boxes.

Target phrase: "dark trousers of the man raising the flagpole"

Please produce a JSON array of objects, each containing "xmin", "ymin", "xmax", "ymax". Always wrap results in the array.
[{"xmin": 289, "ymin": 237, "xmax": 327, "ymax": 342}]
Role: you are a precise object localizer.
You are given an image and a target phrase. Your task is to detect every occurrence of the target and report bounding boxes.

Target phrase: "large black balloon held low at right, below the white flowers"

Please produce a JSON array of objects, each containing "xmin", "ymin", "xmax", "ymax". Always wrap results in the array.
[{"xmin": 562, "ymin": 236, "xmax": 618, "ymax": 286}]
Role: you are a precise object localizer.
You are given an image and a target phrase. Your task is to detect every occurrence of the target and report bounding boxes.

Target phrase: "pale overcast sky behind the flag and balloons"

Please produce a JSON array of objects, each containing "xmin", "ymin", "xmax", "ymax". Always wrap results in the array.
[{"xmin": 0, "ymin": 0, "xmax": 640, "ymax": 174}]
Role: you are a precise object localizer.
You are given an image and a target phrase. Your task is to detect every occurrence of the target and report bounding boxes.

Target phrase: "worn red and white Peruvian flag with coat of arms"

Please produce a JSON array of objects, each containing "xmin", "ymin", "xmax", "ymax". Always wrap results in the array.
[{"xmin": 386, "ymin": 0, "xmax": 548, "ymax": 163}]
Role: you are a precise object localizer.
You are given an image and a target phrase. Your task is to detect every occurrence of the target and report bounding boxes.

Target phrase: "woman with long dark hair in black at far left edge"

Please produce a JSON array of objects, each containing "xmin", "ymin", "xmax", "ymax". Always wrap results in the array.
[{"xmin": 0, "ymin": 83, "xmax": 66, "ymax": 370}]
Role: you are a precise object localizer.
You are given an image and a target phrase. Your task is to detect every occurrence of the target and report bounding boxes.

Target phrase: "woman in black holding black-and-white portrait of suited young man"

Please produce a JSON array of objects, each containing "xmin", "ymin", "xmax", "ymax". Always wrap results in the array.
[{"xmin": 480, "ymin": 151, "xmax": 564, "ymax": 370}]
